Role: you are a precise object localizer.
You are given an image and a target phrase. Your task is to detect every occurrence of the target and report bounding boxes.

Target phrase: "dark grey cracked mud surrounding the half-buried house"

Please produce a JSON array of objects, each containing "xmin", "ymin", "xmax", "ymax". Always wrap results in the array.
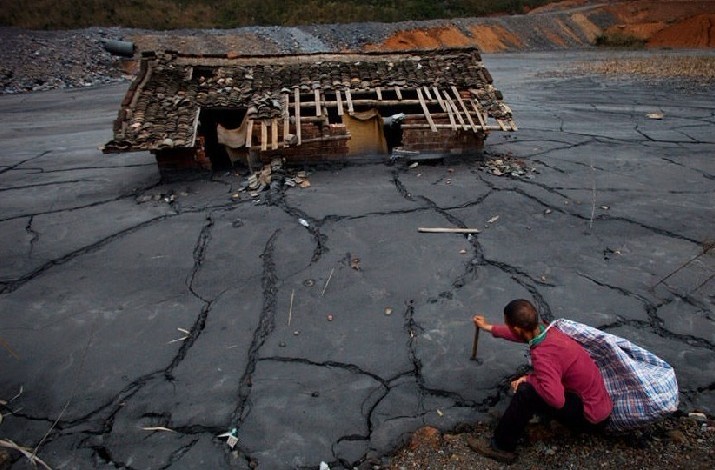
[{"xmin": 0, "ymin": 52, "xmax": 715, "ymax": 469}]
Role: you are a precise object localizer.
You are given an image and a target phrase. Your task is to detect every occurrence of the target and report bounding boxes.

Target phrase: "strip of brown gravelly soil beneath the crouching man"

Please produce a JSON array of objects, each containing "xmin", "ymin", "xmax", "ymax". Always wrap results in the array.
[{"xmin": 392, "ymin": 416, "xmax": 715, "ymax": 470}]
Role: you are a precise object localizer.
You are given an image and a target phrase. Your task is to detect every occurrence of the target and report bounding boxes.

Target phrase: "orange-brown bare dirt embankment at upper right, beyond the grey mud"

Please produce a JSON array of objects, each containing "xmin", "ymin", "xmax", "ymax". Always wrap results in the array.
[{"xmin": 365, "ymin": 0, "xmax": 715, "ymax": 52}]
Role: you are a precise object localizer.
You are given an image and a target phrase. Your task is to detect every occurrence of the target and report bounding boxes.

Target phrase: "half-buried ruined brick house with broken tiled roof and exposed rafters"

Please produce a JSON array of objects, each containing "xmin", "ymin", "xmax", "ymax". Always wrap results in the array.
[{"xmin": 103, "ymin": 48, "xmax": 516, "ymax": 169}]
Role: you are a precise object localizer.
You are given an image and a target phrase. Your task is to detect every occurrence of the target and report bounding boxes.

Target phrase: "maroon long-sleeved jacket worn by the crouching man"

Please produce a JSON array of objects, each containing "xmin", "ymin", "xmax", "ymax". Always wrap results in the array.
[{"xmin": 492, "ymin": 325, "xmax": 613, "ymax": 424}]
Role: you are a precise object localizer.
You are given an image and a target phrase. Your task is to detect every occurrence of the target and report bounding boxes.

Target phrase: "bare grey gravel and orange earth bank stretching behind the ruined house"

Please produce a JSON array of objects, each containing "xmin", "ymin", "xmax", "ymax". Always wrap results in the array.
[{"xmin": 0, "ymin": 0, "xmax": 715, "ymax": 94}]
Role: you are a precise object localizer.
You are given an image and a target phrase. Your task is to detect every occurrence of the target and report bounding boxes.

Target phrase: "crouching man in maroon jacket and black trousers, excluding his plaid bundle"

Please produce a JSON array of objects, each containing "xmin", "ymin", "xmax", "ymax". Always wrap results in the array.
[{"xmin": 467, "ymin": 300, "xmax": 613, "ymax": 463}]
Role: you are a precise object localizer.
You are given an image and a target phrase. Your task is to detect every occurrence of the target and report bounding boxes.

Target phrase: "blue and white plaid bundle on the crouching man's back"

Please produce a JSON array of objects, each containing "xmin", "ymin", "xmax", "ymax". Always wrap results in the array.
[{"xmin": 551, "ymin": 318, "xmax": 678, "ymax": 431}]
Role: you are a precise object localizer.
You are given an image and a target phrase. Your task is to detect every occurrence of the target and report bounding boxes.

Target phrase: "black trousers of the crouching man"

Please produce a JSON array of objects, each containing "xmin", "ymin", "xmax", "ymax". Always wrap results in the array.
[{"xmin": 494, "ymin": 382, "xmax": 606, "ymax": 452}]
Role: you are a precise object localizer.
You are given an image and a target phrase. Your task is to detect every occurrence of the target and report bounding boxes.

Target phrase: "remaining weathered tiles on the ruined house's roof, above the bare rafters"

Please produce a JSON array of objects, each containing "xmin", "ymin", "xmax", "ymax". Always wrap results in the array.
[{"xmin": 104, "ymin": 48, "xmax": 515, "ymax": 152}]
